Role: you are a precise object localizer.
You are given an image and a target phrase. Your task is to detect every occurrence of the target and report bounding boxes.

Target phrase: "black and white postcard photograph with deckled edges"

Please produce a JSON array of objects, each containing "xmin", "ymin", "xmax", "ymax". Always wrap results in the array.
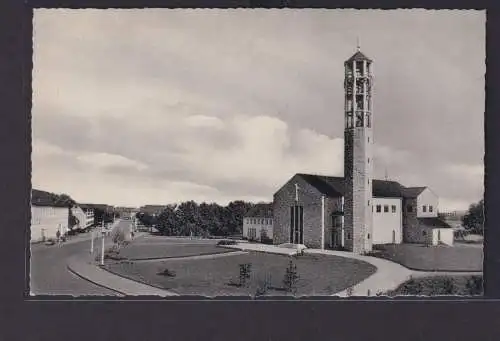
[{"xmin": 30, "ymin": 8, "xmax": 486, "ymax": 298}]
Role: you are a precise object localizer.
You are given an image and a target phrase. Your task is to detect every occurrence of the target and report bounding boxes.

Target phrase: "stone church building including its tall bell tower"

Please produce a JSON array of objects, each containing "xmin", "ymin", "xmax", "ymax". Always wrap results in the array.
[{"xmin": 273, "ymin": 48, "xmax": 453, "ymax": 254}]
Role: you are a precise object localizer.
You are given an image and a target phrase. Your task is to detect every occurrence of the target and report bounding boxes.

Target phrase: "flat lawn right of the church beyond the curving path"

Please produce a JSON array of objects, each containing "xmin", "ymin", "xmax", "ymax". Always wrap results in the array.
[{"xmin": 371, "ymin": 244, "xmax": 483, "ymax": 272}]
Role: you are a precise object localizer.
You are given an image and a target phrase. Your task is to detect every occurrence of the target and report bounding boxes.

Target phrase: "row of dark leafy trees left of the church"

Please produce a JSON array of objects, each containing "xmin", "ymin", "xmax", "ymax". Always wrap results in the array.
[{"xmin": 137, "ymin": 200, "xmax": 257, "ymax": 237}]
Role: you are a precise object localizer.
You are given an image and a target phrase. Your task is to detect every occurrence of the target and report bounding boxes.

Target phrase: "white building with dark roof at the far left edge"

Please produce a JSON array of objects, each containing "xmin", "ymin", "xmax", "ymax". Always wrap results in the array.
[{"xmin": 30, "ymin": 189, "xmax": 69, "ymax": 243}]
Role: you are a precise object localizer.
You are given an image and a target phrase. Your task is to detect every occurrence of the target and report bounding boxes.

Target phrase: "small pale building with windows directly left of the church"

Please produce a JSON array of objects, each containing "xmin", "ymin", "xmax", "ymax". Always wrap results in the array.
[{"xmin": 243, "ymin": 204, "xmax": 273, "ymax": 241}]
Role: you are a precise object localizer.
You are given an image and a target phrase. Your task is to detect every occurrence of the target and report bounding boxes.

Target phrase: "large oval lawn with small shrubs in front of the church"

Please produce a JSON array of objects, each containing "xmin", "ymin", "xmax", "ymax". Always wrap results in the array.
[{"xmin": 106, "ymin": 252, "xmax": 376, "ymax": 296}]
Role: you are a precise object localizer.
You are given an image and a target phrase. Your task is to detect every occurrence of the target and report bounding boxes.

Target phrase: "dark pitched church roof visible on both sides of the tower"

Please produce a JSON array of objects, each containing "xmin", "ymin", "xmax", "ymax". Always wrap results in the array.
[{"xmin": 297, "ymin": 173, "xmax": 425, "ymax": 198}]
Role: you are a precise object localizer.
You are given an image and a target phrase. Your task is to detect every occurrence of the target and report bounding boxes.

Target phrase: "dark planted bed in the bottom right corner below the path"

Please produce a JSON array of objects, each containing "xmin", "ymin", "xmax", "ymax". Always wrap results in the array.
[{"xmin": 387, "ymin": 276, "xmax": 483, "ymax": 296}]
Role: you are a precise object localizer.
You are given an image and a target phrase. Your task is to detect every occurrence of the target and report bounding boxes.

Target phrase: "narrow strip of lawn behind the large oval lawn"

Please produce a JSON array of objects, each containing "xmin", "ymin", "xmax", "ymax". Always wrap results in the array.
[{"xmin": 120, "ymin": 242, "xmax": 234, "ymax": 260}]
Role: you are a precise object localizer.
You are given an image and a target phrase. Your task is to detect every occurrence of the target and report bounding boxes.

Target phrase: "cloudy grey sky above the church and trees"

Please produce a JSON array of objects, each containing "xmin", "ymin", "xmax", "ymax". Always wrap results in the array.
[{"xmin": 32, "ymin": 9, "xmax": 486, "ymax": 211}]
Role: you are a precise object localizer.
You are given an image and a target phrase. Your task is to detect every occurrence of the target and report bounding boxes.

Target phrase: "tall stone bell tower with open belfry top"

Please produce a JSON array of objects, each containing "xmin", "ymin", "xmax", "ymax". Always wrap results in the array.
[{"xmin": 344, "ymin": 46, "xmax": 373, "ymax": 254}]
